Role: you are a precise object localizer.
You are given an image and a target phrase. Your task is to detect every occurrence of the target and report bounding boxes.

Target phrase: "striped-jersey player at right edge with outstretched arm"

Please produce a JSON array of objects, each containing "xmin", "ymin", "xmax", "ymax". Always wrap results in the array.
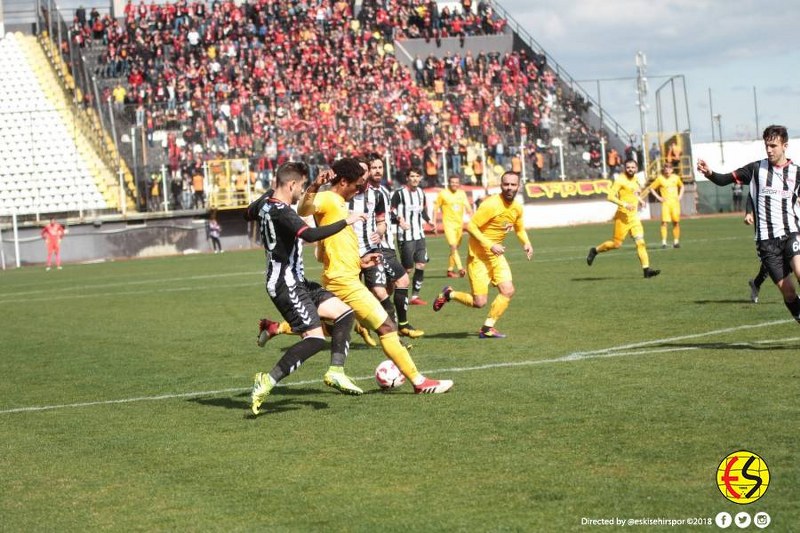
[{"xmin": 697, "ymin": 125, "xmax": 800, "ymax": 323}]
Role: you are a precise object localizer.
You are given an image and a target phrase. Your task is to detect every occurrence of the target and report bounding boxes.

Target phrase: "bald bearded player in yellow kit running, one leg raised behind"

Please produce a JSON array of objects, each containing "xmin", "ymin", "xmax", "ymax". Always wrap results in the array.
[{"xmin": 433, "ymin": 172, "xmax": 533, "ymax": 339}]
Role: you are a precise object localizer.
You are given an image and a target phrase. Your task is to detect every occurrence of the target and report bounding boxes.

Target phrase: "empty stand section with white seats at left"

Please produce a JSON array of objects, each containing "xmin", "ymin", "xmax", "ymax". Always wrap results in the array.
[{"xmin": 0, "ymin": 33, "xmax": 128, "ymax": 215}]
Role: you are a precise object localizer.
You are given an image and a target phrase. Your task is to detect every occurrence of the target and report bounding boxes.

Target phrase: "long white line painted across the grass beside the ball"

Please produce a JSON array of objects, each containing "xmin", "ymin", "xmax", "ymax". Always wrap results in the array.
[{"xmin": 0, "ymin": 320, "xmax": 798, "ymax": 415}]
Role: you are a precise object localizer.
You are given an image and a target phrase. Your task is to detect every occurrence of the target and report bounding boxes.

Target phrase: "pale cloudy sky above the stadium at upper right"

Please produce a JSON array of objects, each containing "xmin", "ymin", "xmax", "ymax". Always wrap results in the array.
[{"xmin": 497, "ymin": 0, "xmax": 800, "ymax": 142}]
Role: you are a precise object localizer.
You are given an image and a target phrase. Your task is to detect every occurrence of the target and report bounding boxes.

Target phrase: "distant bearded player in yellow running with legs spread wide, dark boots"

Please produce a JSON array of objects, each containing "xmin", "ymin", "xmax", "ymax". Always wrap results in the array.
[{"xmin": 586, "ymin": 159, "xmax": 661, "ymax": 278}]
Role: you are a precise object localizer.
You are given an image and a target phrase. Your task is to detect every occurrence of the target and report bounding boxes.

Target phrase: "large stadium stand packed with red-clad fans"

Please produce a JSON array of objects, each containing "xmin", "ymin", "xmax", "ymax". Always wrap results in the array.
[{"xmin": 1, "ymin": 0, "xmax": 636, "ymax": 218}]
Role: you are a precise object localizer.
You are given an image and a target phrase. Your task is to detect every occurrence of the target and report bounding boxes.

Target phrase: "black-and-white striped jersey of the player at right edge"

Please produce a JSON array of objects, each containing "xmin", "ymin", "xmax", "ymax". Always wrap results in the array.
[{"xmin": 733, "ymin": 159, "xmax": 800, "ymax": 241}]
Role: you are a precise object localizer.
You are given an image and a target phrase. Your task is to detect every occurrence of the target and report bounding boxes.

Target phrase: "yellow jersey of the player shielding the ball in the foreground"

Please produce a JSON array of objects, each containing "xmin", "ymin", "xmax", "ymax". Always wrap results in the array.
[{"xmin": 306, "ymin": 191, "xmax": 361, "ymax": 279}]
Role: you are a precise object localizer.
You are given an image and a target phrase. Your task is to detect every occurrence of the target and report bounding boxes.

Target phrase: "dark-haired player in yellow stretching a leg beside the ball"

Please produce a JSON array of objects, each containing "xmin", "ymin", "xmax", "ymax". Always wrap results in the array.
[{"xmin": 297, "ymin": 157, "xmax": 453, "ymax": 394}]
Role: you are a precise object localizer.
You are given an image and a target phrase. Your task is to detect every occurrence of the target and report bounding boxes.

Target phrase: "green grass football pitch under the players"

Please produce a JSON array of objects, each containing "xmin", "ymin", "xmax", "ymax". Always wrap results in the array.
[{"xmin": 0, "ymin": 217, "xmax": 800, "ymax": 532}]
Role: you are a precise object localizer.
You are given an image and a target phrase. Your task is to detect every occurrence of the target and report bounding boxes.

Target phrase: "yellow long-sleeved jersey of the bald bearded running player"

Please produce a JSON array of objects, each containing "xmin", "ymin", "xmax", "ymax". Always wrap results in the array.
[{"xmin": 467, "ymin": 194, "xmax": 530, "ymax": 255}]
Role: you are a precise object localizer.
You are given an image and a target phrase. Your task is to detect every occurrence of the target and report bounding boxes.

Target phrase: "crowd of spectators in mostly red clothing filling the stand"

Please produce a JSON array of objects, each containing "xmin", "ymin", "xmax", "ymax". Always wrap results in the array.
[{"xmin": 65, "ymin": 0, "xmax": 604, "ymax": 210}]
